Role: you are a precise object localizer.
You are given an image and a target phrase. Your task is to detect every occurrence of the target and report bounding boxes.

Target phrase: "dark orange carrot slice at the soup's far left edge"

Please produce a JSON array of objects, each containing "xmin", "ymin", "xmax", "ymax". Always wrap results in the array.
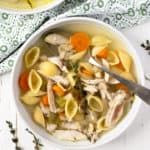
[{"xmin": 19, "ymin": 73, "xmax": 29, "ymax": 91}]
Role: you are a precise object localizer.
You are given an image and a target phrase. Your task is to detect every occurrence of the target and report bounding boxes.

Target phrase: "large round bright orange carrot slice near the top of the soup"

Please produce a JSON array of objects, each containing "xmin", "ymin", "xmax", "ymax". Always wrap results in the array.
[{"xmin": 70, "ymin": 32, "xmax": 90, "ymax": 52}]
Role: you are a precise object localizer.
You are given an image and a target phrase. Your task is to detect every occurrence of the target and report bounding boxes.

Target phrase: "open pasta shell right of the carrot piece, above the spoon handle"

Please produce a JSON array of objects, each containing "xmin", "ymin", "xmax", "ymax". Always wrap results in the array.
[{"xmin": 106, "ymin": 51, "xmax": 120, "ymax": 66}]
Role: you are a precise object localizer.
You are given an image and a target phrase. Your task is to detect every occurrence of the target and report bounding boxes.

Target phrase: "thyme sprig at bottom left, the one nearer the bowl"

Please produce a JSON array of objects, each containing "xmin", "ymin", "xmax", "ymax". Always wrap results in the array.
[{"xmin": 26, "ymin": 128, "xmax": 43, "ymax": 150}]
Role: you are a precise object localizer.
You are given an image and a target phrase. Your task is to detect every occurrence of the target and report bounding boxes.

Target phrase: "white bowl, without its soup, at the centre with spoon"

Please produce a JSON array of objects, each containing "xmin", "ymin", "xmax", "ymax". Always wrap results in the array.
[{"xmin": 11, "ymin": 17, "xmax": 144, "ymax": 150}]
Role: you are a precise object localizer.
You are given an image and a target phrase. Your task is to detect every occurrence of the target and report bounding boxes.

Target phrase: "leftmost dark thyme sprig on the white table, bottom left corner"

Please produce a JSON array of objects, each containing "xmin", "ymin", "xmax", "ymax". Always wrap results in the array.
[{"xmin": 6, "ymin": 121, "xmax": 22, "ymax": 150}]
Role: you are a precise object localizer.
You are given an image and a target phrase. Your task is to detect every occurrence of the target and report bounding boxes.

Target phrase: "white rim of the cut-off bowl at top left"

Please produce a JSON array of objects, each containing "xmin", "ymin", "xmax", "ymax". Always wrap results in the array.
[{"xmin": 0, "ymin": 0, "xmax": 64, "ymax": 15}]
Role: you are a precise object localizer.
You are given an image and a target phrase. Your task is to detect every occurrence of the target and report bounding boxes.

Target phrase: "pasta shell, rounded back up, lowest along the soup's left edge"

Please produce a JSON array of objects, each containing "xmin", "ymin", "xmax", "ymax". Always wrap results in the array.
[{"xmin": 33, "ymin": 106, "xmax": 45, "ymax": 127}]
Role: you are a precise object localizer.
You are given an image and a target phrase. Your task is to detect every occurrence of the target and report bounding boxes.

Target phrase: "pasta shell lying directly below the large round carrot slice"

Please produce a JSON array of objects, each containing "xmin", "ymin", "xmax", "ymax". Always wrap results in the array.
[{"xmin": 69, "ymin": 50, "xmax": 87, "ymax": 62}]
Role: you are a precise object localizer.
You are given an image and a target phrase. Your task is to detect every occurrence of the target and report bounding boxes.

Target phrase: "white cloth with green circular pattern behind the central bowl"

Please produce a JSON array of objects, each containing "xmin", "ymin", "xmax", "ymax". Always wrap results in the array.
[{"xmin": 0, "ymin": 0, "xmax": 150, "ymax": 74}]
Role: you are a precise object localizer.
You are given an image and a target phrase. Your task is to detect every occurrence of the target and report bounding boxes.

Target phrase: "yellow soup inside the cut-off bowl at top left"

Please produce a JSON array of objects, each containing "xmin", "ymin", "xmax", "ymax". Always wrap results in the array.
[{"xmin": 0, "ymin": 0, "xmax": 54, "ymax": 10}]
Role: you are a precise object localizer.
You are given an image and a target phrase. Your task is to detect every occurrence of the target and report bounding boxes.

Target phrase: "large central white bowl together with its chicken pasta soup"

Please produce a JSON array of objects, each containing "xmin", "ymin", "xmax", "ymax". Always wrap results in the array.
[{"xmin": 12, "ymin": 18, "xmax": 144, "ymax": 149}]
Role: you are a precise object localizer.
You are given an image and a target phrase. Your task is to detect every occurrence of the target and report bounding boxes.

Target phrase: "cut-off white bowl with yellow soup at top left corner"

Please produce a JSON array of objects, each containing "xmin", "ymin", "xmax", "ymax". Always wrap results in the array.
[{"xmin": 0, "ymin": 0, "xmax": 64, "ymax": 14}]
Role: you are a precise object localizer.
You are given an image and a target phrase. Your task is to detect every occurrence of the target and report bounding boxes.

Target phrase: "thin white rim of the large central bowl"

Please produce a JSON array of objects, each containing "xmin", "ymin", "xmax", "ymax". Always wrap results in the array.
[{"xmin": 11, "ymin": 17, "xmax": 145, "ymax": 150}]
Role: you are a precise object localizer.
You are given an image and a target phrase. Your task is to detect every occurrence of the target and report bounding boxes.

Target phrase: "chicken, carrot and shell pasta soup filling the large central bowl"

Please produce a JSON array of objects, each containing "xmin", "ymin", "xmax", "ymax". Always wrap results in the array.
[{"xmin": 19, "ymin": 31, "xmax": 136, "ymax": 142}]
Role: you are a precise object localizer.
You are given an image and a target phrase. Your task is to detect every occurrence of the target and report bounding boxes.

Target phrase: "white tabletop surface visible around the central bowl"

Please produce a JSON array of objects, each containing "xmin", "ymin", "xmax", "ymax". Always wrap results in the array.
[{"xmin": 0, "ymin": 22, "xmax": 150, "ymax": 150}]
